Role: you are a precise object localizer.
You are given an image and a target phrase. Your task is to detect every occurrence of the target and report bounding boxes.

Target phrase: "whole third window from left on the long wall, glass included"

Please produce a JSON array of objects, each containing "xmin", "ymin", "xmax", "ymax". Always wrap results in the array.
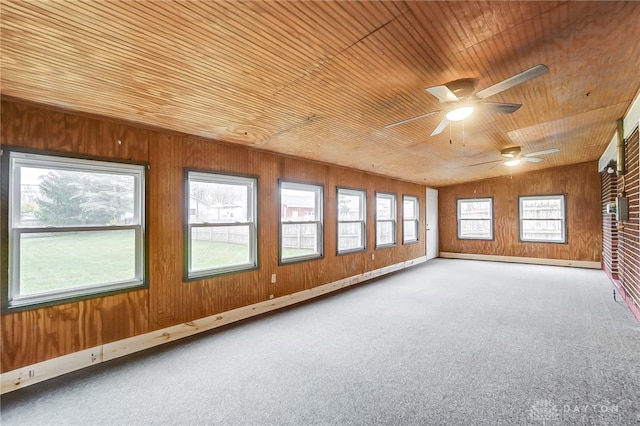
[{"xmin": 280, "ymin": 182, "xmax": 323, "ymax": 263}]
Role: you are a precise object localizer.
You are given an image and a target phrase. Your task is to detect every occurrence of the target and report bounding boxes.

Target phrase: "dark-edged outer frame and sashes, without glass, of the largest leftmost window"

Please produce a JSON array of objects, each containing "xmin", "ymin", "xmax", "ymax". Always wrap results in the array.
[{"xmin": 0, "ymin": 146, "xmax": 149, "ymax": 312}]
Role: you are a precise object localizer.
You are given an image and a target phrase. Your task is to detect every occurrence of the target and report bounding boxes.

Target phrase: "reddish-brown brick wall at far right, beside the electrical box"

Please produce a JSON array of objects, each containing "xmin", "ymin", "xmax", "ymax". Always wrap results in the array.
[{"xmin": 618, "ymin": 127, "xmax": 640, "ymax": 308}]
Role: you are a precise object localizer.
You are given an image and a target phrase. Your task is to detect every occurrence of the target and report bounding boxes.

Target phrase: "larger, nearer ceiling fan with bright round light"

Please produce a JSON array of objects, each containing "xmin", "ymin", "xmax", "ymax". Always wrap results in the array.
[{"xmin": 384, "ymin": 64, "xmax": 549, "ymax": 136}]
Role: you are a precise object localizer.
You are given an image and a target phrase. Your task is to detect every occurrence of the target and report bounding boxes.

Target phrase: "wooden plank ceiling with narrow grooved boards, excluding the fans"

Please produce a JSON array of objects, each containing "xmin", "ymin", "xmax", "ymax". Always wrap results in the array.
[{"xmin": 1, "ymin": 0, "xmax": 640, "ymax": 186}]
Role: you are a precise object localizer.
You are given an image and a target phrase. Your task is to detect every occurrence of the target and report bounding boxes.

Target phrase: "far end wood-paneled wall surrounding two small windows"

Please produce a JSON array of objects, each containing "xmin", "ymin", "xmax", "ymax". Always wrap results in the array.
[{"xmin": 438, "ymin": 162, "xmax": 602, "ymax": 262}]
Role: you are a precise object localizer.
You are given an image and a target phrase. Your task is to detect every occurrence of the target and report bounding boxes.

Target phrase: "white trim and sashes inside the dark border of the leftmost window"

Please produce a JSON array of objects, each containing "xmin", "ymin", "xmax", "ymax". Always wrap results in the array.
[{"xmin": 6, "ymin": 151, "xmax": 145, "ymax": 309}]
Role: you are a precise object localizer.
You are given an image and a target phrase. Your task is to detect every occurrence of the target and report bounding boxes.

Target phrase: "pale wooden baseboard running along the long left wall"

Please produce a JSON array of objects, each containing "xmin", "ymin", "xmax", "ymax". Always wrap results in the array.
[{"xmin": 0, "ymin": 256, "xmax": 427, "ymax": 394}]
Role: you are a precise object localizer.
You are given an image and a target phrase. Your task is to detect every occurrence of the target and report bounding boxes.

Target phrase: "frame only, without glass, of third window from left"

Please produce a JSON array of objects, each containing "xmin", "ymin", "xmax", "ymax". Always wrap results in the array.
[{"xmin": 278, "ymin": 179, "xmax": 324, "ymax": 265}]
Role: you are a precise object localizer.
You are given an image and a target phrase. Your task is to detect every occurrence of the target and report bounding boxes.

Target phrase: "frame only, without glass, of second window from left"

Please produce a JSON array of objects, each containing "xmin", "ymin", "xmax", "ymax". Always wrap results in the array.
[{"xmin": 184, "ymin": 168, "xmax": 259, "ymax": 281}]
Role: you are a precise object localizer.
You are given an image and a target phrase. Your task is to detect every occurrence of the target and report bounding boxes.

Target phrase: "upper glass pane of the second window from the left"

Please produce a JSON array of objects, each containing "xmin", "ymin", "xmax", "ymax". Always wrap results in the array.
[{"xmin": 189, "ymin": 180, "xmax": 251, "ymax": 223}]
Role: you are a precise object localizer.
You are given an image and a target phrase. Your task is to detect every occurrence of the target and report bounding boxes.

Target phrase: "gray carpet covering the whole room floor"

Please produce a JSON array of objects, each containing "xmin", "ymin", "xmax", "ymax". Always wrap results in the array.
[{"xmin": 1, "ymin": 259, "xmax": 640, "ymax": 425}]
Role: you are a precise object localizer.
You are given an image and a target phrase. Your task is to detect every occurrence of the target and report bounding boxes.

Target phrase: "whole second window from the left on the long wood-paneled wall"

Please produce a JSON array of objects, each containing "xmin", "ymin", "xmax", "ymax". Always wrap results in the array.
[{"xmin": 186, "ymin": 171, "xmax": 258, "ymax": 279}]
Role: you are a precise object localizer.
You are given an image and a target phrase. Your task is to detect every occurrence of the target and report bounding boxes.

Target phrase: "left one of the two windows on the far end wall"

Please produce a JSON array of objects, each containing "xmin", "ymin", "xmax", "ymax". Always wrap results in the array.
[{"xmin": 457, "ymin": 198, "xmax": 493, "ymax": 240}]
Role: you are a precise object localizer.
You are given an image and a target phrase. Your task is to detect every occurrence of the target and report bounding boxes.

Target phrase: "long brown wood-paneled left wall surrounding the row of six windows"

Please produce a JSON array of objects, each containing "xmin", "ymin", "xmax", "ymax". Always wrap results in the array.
[{"xmin": 0, "ymin": 100, "xmax": 425, "ymax": 372}]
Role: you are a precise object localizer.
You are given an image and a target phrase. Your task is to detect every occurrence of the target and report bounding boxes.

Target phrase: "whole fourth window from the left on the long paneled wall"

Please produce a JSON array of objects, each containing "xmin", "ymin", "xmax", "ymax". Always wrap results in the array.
[{"xmin": 338, "ymin": 188, "xmax": 367, "ymax": 254}]
